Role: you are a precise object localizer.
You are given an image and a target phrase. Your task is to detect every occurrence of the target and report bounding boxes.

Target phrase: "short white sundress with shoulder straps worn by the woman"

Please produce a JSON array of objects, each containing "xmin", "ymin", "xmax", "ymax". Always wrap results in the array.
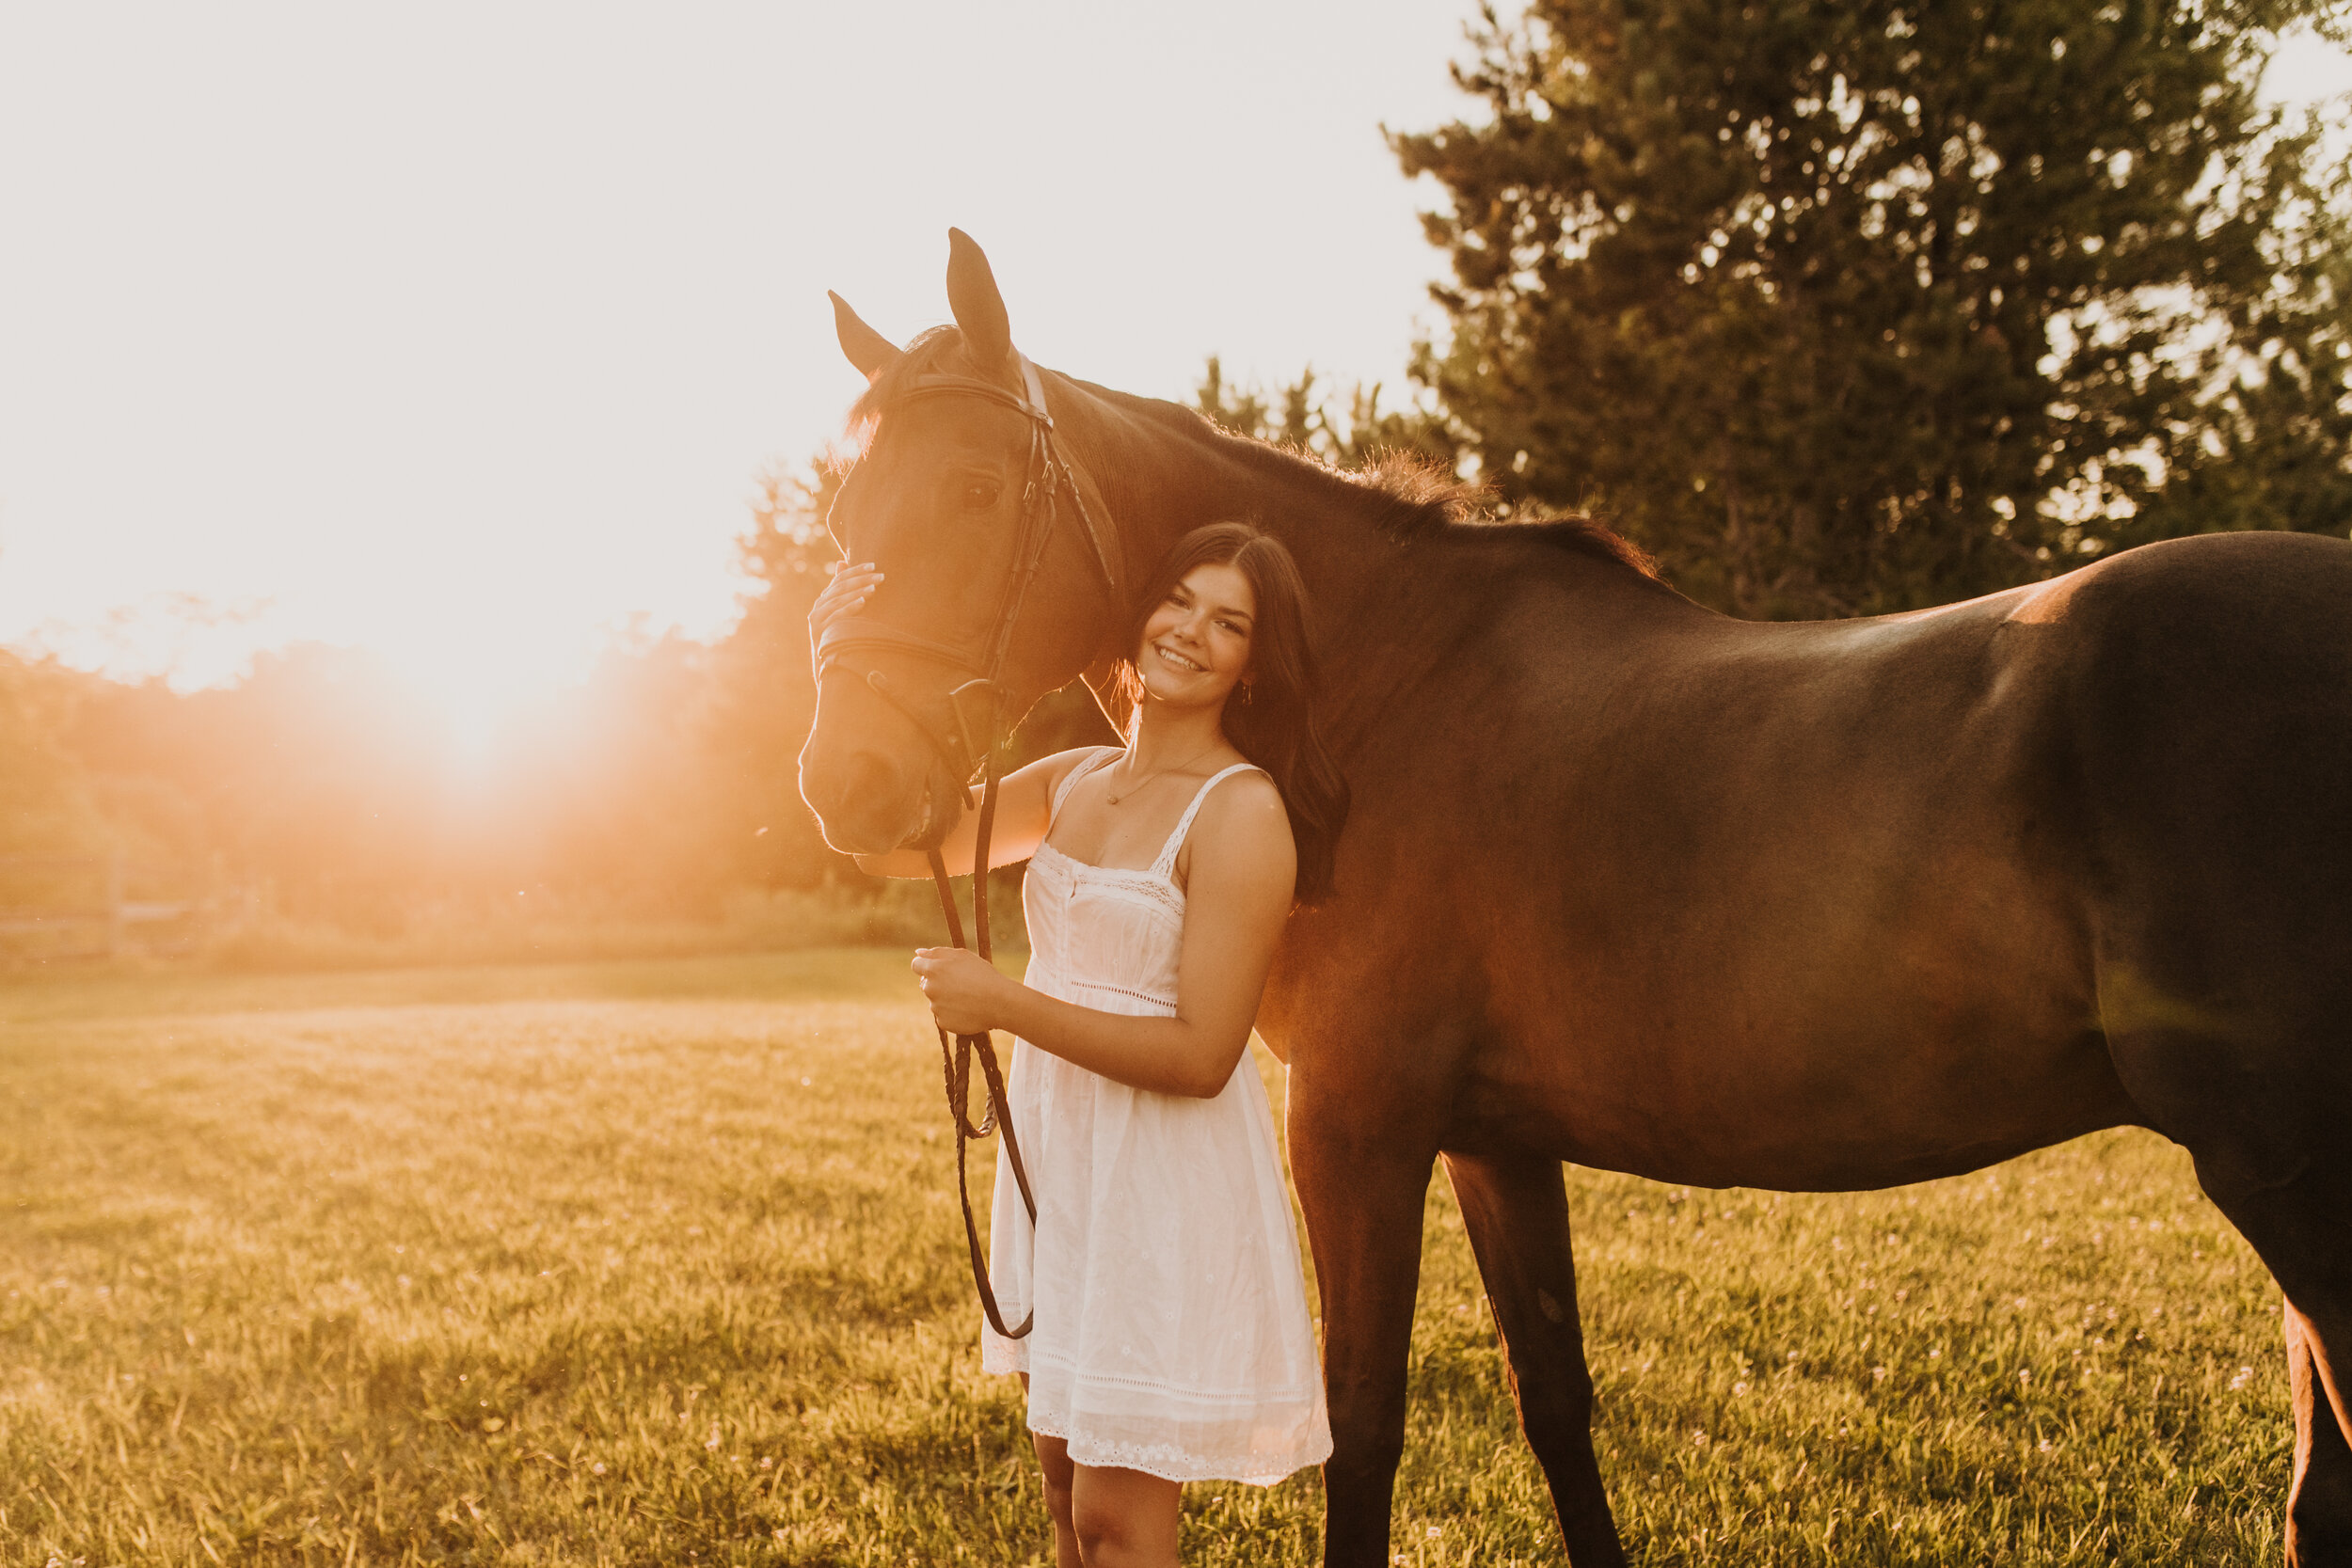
[{"xmin": 981, "ymin": 745, "xmax": 1331, "ymax": 1486}]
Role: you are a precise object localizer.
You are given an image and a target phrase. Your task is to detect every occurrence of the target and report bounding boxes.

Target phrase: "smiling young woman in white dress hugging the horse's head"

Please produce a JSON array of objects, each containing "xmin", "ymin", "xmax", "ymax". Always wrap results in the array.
[{"xmin": 809, "ymin": 522, "xmax": 1348, "ymax": 1568}]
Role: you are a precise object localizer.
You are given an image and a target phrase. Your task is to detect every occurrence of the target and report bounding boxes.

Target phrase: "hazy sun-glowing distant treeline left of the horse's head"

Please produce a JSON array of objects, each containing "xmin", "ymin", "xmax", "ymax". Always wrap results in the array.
[{"xmin": 0, "ymin": 460, "xmax": 1104, "ymax": 933}]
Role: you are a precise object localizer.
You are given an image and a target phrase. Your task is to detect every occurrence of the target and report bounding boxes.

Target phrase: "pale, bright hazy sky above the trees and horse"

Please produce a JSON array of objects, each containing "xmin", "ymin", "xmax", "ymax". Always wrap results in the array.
[{"xmin": 0, "ymin": 0, "xmax": 2352, "ymax": 747}]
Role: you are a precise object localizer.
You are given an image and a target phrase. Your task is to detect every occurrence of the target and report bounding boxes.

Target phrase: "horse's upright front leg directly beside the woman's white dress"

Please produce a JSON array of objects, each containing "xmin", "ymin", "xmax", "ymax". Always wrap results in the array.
[{"xmin": 1289, "ymin": 1068, "xmax": 1438, "ymax": 1568}]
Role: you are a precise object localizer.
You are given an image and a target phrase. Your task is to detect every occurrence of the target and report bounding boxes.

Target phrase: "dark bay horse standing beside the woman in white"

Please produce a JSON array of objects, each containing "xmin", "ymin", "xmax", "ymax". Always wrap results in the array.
[{"xmin": 800, "ymin": 232, "xmax": 2352, "ymax": 1568}]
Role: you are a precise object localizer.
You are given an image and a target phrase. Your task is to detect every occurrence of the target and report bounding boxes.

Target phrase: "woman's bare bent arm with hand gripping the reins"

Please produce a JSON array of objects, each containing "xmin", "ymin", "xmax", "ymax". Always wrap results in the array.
[{"xmin": 915, "ymin": 773, "xmax": 1298, "ymax": 1098}]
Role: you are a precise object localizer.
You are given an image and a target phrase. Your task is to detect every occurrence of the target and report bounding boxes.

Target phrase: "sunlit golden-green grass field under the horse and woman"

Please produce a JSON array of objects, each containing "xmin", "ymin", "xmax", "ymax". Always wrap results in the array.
[{"xmin": 0, "ymin": 950, "xmax": 2289, "ymax": 1568}]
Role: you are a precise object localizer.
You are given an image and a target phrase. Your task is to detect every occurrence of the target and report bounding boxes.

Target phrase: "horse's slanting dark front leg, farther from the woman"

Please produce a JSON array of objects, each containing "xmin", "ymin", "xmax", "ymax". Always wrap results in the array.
[{"xmin": 1447, "ymin": 1154, "xmax": 1626, "ymax": 1568}]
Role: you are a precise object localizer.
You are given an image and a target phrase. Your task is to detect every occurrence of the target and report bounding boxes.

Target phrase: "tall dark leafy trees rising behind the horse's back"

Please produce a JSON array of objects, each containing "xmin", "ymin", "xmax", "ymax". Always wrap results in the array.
[{"xmin": 1395, "ymin": 0, "xmax": 2352, "ymax": 616}]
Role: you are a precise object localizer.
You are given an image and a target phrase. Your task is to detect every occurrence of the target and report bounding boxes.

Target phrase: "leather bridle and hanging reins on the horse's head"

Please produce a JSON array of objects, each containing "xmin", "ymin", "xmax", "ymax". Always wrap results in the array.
[{"xmin": 817, "ymin": 355, "xmax": 1127, "ymax": 1340}]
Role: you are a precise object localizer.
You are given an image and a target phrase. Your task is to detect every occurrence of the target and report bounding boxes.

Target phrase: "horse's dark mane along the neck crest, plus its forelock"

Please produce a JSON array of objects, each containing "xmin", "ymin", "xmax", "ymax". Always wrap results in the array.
[{"xmin": 847, "ymin": 326, "xmax": 1659, "ymax": 580}]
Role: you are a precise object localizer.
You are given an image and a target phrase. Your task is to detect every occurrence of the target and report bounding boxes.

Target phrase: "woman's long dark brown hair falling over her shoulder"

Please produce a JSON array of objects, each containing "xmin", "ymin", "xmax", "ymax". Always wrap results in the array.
[{"xmin": 1118, "ymin": 522, "xmax": 1348, "ymax": 903}]
